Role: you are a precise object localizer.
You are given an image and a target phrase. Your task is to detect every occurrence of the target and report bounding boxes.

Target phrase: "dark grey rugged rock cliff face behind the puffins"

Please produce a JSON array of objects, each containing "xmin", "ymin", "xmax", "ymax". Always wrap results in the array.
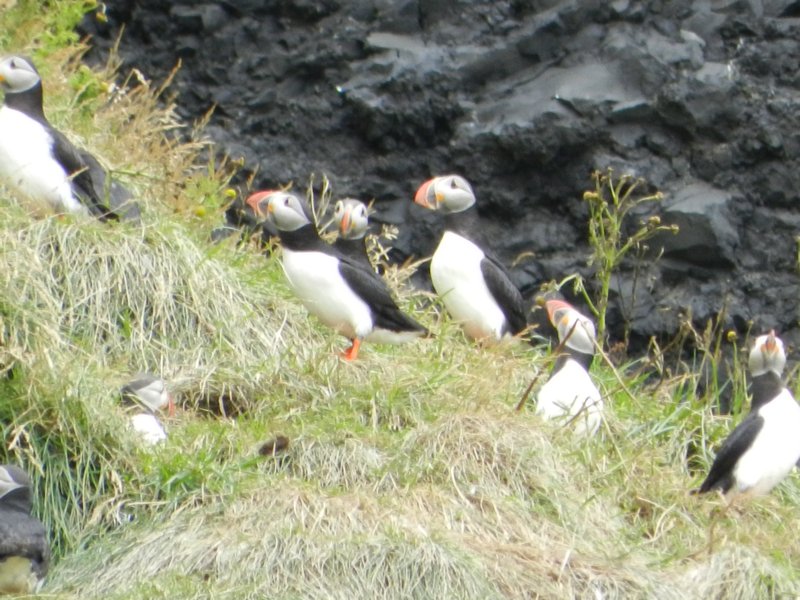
[{"xmin": 83, "ymin": 0, "xmax": 800, "ymax": 354}]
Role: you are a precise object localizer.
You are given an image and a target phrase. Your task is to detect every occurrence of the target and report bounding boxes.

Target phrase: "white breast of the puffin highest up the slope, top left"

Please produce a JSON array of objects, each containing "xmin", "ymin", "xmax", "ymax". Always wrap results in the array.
[{"xmin": 0, "ymin": 106, "xmax": 86, "ymax": 213}]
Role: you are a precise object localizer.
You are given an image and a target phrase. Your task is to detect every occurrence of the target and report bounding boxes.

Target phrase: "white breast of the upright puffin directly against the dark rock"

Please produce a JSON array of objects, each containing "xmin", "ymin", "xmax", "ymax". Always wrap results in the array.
[{"xmin": 431, "ymin": 231, "xmax": 506, "ymax": 340}]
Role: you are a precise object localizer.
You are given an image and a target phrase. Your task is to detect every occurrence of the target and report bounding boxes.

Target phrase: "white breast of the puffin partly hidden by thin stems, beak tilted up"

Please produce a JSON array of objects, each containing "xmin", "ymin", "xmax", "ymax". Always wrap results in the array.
[{"xmin": 536, "ymin": 358, "xmax": 603, "ymax": 435}]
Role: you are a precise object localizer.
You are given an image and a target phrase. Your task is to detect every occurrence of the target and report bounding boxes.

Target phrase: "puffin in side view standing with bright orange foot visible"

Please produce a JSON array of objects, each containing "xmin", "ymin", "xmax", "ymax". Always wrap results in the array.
[{"xmin": 255, "ymin": 192, "xmax": 428, "ymax": 361}]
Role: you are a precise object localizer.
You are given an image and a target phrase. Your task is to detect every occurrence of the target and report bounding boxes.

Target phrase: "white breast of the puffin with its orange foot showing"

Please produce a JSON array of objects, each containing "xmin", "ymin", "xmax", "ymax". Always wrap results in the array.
[{"xmin": 283, "ymin": 248, "xmax": 372, "ymax": 339}]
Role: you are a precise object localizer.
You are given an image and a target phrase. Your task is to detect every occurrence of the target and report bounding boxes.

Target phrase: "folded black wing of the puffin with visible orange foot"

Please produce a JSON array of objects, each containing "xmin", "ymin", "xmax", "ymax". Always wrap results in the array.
[{"xmin": 339, "ymin": 258, "xmax": 428, "ymax": 334}]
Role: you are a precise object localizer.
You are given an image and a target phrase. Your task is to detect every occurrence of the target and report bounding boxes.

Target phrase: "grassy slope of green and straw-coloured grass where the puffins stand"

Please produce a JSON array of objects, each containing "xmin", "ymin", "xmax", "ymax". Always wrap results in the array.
[{"xmin": 0, "ymin": 1, "xmax": 800, "ymax": 600}]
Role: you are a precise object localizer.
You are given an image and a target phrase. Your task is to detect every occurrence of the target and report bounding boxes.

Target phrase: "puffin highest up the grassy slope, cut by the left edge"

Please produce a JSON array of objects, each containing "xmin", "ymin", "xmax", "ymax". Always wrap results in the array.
[{"xmin": 0, "ymin": 56, "xmax": 141, "ymax": 222}]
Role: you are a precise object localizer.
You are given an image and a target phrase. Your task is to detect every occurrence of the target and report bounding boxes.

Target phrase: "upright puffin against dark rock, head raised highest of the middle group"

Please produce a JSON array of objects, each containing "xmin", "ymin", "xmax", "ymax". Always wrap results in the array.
[{"xmin": 414, "ymin": 175, "xmax": 527, "ymax": 340}]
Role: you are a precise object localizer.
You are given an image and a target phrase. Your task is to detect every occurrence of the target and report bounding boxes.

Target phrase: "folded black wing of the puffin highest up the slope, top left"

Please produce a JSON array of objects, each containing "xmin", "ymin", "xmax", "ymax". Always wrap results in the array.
[{"xmin": 50, "ymin": 128, "xmax": 141, "ymax": 222}]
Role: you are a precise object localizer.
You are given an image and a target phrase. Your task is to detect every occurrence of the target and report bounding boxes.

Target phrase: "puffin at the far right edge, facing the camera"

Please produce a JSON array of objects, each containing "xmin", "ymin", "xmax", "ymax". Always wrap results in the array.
[{"xmin": 692, "ymin": 331, "xmax": 800, "ymax": 503}]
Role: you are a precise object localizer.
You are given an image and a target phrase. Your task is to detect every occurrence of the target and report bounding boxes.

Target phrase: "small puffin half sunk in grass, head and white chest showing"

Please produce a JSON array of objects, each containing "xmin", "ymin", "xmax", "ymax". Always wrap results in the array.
[{"xmin": 120, "ymin": 373, "xmax": 175, "ymax": 444}]
